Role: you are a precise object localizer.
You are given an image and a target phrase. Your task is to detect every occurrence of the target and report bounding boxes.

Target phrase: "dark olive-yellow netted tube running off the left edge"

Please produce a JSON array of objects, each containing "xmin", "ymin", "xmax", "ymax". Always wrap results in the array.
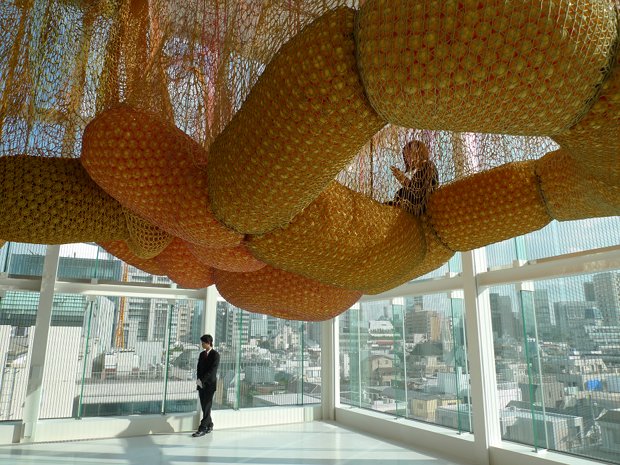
[{"xmin": 0, "ymin": 156, "xmax": 129, "ymax": 244}]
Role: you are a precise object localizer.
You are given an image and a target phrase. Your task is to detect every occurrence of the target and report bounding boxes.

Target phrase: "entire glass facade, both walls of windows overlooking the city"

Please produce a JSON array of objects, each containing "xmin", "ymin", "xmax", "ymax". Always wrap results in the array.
[{"xmin": 0, "ymin": 211, "xmax": 620, "ymax": 464}]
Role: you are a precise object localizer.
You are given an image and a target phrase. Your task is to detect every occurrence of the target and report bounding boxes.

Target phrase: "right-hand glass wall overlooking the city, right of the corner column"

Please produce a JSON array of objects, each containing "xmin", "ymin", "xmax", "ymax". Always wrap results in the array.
[{"xmin": 340, "ymin": 217, "xmax": 620, "ymax": 463}]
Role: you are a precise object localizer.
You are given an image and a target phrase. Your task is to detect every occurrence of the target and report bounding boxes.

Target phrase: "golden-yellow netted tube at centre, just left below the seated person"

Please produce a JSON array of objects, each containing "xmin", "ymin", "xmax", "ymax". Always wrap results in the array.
[{"xmin": 248, "ymin": 182, "xmax": 425, "ymax": 291}]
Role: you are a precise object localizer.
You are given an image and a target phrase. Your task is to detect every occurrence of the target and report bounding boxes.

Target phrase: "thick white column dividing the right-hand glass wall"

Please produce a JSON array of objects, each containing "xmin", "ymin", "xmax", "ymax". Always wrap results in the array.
[{"xmin": 461, "ymin": 249, "xmax": 501, "ymax": 464}]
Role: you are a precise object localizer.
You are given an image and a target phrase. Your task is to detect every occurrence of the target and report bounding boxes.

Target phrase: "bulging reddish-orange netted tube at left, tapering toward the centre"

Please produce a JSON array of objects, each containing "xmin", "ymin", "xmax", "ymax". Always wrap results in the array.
[{"xmin": 81, "ymin": 105, "xmax": 242, "ymax": 247}]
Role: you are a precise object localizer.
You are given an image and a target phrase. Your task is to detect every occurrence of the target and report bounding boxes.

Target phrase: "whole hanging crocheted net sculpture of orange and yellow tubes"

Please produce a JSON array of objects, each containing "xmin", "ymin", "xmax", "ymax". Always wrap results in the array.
[{"xmin": 0, "ymin": 0, "xmax": 620, "ymax": 320}]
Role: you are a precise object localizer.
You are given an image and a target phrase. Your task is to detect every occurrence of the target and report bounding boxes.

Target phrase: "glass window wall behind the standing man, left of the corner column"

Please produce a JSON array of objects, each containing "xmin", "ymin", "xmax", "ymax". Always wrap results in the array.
[{"xmin": 0, "ymin": 243, "xmax": 321, "ymax": 421}]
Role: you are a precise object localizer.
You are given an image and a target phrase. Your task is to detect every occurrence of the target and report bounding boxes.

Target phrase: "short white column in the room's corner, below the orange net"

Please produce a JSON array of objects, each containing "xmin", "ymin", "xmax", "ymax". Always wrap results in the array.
[{"xmin": 321, "ymin": 317, "xmax": 340, "ymax": 420}]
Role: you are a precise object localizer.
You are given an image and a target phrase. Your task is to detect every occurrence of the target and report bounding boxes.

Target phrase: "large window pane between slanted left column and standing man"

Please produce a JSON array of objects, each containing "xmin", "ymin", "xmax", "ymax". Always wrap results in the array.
[{"xmin": 28, "ymin": 294, "xmax": 202, "ymax": 418}]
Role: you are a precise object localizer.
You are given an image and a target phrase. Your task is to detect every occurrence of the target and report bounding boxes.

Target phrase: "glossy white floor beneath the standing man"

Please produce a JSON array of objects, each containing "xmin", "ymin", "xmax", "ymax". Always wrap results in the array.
[{"xmin": 0, "ymin": 422, "xmax": 454, "ymax": 465}]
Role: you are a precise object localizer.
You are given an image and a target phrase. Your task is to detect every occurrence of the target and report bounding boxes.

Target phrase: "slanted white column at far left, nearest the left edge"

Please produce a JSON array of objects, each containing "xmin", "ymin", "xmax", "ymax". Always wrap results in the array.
[{"xmin": 22, "ymin": 245, "xmax": 60, "ymax": 442}]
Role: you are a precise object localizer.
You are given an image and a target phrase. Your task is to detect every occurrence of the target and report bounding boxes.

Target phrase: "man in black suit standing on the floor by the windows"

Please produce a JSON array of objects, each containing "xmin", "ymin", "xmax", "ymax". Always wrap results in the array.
[{"xmin": 192, "ymin": 334, "xmax": 220, "ymax": 438}]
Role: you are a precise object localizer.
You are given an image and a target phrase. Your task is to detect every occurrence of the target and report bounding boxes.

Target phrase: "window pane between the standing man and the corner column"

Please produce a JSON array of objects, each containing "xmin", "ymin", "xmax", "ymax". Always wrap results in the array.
[{"xmin": 214, "ymin": 300, "xmax": 321, "ymax": 409}]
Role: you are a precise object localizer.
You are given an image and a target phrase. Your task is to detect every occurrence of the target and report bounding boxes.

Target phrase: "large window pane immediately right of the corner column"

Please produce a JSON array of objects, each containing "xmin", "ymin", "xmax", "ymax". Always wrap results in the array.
[{"xmin": 340, "ymin": 293, "xmax": 471, "ymax": 431}]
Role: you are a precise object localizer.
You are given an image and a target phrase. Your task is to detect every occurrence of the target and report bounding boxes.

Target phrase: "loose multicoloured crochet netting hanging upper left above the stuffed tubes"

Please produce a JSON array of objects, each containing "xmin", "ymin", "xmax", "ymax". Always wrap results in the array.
[{"xmin": 0, "ymin": 0, "xmax": 352, "ymax": 157}]
